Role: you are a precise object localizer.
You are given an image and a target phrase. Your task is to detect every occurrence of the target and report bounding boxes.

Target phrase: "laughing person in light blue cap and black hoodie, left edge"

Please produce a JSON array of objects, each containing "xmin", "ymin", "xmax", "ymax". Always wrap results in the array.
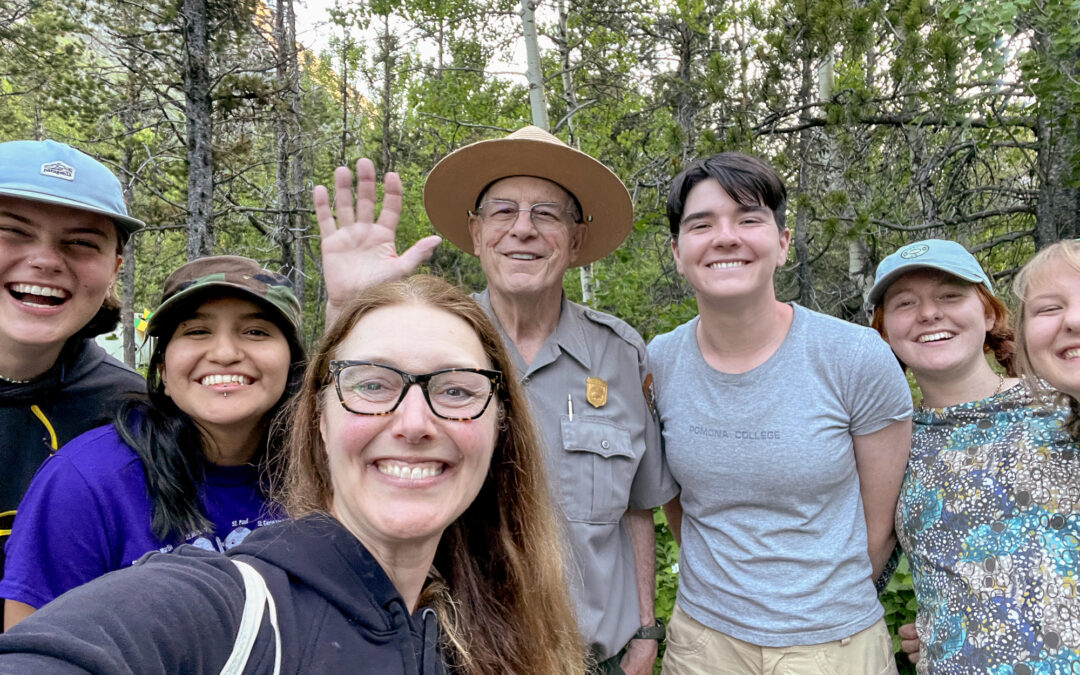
[{"xmin": 0, "ymin": 140, "xmax": 145, "ymax": 622}]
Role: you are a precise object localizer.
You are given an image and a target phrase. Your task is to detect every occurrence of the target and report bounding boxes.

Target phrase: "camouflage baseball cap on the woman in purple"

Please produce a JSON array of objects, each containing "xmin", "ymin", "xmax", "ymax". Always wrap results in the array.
[{"xmin": 146, "ymin": 256, "xmax": 300, "ymax": 341}]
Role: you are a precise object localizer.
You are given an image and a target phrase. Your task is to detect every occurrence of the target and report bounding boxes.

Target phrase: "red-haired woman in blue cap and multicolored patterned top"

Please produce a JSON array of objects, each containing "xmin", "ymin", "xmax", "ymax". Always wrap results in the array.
[{"xmin": 869, "ymin": 240, "xmax": 1080, "ymax": 674}]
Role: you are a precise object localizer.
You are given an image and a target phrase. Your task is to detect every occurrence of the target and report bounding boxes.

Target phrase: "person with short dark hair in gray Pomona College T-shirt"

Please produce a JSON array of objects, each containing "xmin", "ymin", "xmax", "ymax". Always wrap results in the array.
[{"xmin": 649, "ymin": 152, "xmax": 912, "ymax": 675}]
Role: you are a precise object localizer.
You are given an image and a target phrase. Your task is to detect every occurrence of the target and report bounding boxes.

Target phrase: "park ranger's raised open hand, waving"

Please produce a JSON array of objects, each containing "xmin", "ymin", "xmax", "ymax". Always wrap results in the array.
[{"xmin": 312, "ymin": 158, "xmax": 442, "ymax": 326}]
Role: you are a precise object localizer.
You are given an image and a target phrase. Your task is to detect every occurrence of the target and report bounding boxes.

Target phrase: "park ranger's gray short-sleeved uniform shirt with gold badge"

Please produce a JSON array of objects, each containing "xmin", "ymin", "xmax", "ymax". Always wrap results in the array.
[{"xmin": 473, "ymin": 291, "xmax": 678, "ymax": 659}]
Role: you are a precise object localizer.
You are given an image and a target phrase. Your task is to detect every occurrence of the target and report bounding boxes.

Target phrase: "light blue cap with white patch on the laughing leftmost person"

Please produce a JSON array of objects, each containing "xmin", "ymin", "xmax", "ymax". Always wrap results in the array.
[{"xmin": 0, "ymin": 140, "xmax": 146, "ymax": 237}]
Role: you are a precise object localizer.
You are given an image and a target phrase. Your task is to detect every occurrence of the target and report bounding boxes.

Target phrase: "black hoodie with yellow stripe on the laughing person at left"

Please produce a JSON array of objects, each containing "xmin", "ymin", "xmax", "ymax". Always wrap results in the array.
[{"xmin": 0, "ymin": 337, "xmax": 146, "ymax": 570}]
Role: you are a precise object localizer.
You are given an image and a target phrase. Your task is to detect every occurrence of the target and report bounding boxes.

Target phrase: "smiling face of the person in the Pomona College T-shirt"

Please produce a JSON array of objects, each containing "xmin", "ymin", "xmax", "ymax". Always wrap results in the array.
[{"xmin": 672, "ymin": 178, "xmax": 791, "ymax": 302}]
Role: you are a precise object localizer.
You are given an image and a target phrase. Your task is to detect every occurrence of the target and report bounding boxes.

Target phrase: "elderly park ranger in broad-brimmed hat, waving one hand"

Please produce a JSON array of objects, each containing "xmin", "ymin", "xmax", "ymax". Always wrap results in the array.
[{"xmin": 314, "ymin": 126, "xmax": 676, "ymax": 674}]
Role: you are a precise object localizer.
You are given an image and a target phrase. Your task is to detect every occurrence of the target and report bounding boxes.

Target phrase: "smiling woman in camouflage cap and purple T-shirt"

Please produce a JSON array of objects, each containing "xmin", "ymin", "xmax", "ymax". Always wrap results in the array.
[{"xmin": 0, "ymin": 256, "xmax": 303, "ymax": 627}]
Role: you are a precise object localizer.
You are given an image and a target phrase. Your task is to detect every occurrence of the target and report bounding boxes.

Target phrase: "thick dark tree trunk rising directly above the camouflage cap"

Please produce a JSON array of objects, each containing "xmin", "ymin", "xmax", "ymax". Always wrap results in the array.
[{"xmin": 180, "ymin": 0, "xmax": 214, "ymax": 260}]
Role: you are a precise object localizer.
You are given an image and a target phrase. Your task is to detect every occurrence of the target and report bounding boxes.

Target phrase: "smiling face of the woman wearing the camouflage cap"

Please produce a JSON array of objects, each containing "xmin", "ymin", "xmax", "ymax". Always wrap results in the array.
[{"xmin": 161, "ymin": 296, "xmax": 291, "ymax": 447}]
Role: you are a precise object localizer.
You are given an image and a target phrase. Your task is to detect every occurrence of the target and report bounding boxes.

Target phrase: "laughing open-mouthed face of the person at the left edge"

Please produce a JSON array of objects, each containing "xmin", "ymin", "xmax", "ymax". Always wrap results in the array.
[{"xmin": 0, "ymin": 197, "xmax": 120, "ymax": 357}]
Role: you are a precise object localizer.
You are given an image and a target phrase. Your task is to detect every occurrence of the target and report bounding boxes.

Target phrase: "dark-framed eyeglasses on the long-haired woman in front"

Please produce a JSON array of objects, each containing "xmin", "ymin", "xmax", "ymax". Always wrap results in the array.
[{"xmin": 330, "ymin": 361, "xmax": 502, "ymax": 421}]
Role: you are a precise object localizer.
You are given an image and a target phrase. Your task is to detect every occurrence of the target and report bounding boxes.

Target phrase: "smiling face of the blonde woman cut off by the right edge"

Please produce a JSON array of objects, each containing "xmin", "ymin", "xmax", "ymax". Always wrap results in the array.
[{"xmin": 1023, "ymin": 257, "xmax": 1080, "ymax": 399}]
